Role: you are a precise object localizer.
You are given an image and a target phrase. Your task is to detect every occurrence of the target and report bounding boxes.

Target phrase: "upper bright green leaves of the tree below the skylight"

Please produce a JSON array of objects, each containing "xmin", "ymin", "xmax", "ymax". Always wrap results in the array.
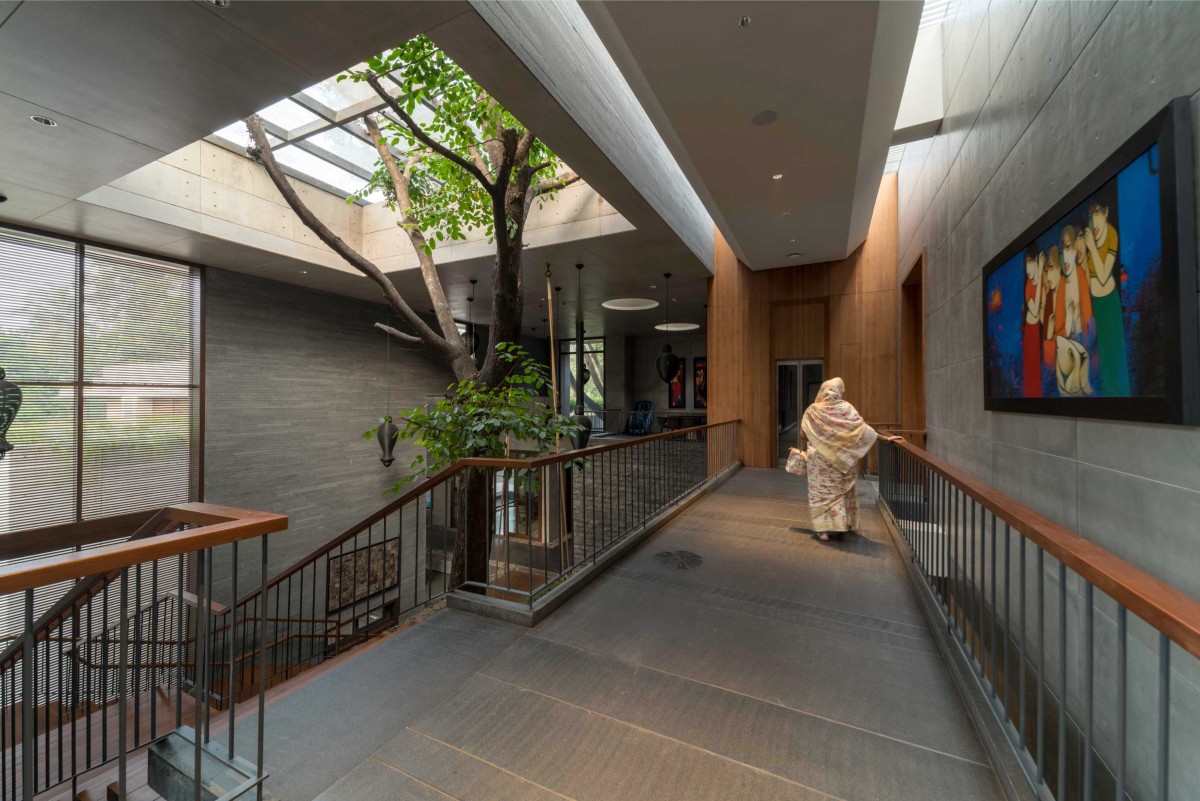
[{"xmin": 337, "ymin": 35, "xmax": 560, "ymax": 253}]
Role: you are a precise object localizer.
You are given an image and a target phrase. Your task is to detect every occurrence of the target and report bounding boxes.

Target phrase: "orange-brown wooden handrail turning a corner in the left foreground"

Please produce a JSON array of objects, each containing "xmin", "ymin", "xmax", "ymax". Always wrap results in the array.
[{"xmin": 0, "ymin": 504, "xmax": 288, "ymax": 595}]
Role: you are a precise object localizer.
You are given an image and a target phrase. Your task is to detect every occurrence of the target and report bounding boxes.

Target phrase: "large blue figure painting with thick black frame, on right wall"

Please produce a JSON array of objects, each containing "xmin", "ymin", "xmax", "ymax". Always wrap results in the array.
[{"xmin": 983, "ymin": 98, "xmax": 1200, "ymax": 426}]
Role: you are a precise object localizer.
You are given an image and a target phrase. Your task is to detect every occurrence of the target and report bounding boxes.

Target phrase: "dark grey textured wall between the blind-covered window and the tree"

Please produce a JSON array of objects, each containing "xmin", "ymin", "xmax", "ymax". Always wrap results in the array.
[{"xmin": 204, "ymin": 269, "xmax": 452, "ymax": 586}]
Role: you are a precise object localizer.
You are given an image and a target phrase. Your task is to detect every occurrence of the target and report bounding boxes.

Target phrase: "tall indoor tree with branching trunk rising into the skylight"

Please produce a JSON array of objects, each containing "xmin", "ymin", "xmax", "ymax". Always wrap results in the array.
[{"xmin": 246, "ymin": 36, "xmax": 580, "ymax": 584}]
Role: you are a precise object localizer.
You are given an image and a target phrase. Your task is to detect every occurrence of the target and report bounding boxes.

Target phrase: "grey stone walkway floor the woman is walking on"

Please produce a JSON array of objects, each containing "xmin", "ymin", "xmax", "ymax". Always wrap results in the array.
[{"xmin": 260, "ymin": 470, "xmax": 1002, "ymax": 801}]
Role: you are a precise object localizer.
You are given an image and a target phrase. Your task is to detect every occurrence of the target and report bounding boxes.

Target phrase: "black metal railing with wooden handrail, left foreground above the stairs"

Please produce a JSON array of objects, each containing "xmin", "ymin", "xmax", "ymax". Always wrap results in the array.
[{"xmin": 0, "ymin": 504, "xmax": 287, "ymax": 800}]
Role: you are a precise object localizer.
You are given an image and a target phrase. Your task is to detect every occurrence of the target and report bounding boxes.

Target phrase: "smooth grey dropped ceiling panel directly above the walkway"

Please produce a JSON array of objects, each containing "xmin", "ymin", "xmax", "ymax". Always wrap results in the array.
[{"xmin": 582, "ymin": 0, "xmax": 922, "ymax": 270}]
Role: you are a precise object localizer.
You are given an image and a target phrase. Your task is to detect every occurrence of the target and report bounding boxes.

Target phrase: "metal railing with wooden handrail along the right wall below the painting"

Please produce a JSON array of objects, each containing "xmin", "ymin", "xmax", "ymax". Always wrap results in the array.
[{"xmin": 878, "ymin": 438, "xmax": 1200, "ymax": 801}]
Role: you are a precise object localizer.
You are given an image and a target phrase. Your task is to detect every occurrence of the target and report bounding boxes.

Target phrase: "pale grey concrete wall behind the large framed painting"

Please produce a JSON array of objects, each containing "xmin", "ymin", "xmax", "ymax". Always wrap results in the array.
[{"xmin": 898, "ymin": 0, "xmax": 1200, "ymax": 797}]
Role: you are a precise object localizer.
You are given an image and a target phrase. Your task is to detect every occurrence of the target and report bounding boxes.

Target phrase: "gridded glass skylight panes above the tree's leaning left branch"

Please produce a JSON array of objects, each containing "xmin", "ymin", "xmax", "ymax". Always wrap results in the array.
[{"xmin": 206, "ymin": 64, "xmax": 433, "ymax": 203}]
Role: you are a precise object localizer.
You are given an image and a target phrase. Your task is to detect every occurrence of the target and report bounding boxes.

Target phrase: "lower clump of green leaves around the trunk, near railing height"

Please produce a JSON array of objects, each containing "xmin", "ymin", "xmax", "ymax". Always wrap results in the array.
[{"xmin": 362, "ymin": 342, "xmax": 576, "ymax": 493}]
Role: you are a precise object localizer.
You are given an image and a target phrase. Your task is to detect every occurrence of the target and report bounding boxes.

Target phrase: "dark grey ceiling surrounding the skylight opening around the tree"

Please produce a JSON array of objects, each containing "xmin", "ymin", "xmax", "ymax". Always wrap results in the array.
[{"xmin": 0, "ymin": 0, "xmax": 709, "ymax": 333}]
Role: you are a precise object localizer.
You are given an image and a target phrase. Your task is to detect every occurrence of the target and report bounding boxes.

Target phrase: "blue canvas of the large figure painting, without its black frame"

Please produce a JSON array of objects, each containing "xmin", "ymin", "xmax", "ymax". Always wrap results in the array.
[{"xmin": 984, "ymin": 144, "xmax": 1161, "ymax": 398}]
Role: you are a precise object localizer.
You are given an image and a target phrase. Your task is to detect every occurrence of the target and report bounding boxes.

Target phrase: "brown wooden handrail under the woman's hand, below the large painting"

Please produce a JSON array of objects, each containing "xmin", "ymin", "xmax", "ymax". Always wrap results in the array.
[{"xmin": 892, "ymin": 439, "xmax": 1200, "ymax": 658}]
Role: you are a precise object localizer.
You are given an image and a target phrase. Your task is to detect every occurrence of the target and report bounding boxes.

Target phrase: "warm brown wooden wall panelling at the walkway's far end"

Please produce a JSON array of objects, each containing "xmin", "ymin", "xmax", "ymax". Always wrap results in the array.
[{"xmin": 708, "ymin": 174, "xmax": 899, "ymax": 466}]
